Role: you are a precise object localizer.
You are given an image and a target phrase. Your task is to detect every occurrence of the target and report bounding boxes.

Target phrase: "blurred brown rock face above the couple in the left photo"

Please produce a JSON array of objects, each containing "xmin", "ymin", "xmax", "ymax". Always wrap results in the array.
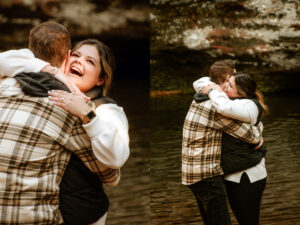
[{"xmin": 0, "ymin": 0, "xmax": 149, "ymax": 49}]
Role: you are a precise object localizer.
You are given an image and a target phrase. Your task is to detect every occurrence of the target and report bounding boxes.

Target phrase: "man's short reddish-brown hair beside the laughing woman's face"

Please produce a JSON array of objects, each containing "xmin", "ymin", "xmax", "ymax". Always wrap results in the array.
[{"xmin": 29, "ymin": 22, "xmax": 71, "ymax": 67}]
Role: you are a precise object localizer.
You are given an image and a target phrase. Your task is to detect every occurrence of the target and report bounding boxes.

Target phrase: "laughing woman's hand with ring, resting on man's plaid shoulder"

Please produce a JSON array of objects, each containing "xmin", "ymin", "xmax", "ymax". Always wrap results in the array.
[{"xmin": 48, "ymin": 90, "xmax": 91, "ymax": 120}]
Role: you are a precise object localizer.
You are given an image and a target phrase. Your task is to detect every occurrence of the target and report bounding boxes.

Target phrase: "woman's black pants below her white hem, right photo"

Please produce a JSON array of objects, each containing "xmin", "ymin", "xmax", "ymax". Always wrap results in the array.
[{"xmin": 225, "ymin": 173, "xmax": 267, "ymax": 225}]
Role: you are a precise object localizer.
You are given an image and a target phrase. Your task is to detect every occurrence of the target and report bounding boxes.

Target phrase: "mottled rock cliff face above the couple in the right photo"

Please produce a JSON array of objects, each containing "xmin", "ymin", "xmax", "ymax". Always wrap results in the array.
[{"xmin": 150, "ymin": 0, "xmax": 300, "ymax": 92}]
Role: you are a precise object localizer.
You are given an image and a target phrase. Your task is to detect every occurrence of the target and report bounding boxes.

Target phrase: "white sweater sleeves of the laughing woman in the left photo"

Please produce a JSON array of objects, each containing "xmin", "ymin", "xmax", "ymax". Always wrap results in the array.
[{"xmin": 0, "ymin": 49, "xmax": 129, "ymax": 169}]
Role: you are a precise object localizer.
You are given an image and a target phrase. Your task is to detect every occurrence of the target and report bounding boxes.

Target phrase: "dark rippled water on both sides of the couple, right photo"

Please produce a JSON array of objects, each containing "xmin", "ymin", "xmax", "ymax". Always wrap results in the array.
[{"xmin": 150, "ymin": 95, "xmax": 300, "ymax": 225}]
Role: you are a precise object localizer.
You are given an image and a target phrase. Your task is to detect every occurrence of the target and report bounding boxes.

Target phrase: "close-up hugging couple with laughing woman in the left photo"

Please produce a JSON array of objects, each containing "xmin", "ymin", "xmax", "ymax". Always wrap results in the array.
[{"xmin": 0, "ymin": 22, "xmax": 129, "ymax": 225}]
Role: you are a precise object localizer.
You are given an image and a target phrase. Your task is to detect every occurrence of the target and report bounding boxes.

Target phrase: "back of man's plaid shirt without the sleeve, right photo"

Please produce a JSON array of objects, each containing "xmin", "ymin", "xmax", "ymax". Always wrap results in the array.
[{"xmin": 182, "ymin": 100, "xmax": 223, "ymax": 185}]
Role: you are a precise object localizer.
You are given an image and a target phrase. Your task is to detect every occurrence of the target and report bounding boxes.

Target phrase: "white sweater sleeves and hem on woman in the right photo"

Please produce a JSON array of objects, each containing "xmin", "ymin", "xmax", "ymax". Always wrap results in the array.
[{"xmin": 193, "ymin": 77, "xmax": 267, "ymax": 183}]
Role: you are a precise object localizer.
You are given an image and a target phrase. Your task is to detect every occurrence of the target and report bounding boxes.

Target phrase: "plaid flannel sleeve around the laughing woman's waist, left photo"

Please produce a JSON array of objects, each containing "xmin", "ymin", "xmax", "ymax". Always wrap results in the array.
[{"xmin": 65, "ymin": 119, "xmax": 121, "ymax": 186}]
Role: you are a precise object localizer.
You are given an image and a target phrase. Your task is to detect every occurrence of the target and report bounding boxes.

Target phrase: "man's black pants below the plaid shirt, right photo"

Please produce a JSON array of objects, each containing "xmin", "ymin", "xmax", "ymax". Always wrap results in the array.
[{"xmin": 188, "ymin": 176, "xmax": 231, "ymax": 225}]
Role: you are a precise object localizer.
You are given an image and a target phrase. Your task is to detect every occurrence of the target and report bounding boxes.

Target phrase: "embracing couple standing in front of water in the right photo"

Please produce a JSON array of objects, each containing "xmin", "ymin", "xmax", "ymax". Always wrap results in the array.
[{"xmin": 182, "ymin": 61, "xmax": 267, "ymax": 225}]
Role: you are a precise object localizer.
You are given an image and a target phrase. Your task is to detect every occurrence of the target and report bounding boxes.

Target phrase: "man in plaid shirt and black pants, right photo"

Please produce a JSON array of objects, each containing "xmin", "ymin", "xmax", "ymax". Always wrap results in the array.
[{"xmin": 182, "ymin": 60, "xmax": 262, "ymax": 225}]
